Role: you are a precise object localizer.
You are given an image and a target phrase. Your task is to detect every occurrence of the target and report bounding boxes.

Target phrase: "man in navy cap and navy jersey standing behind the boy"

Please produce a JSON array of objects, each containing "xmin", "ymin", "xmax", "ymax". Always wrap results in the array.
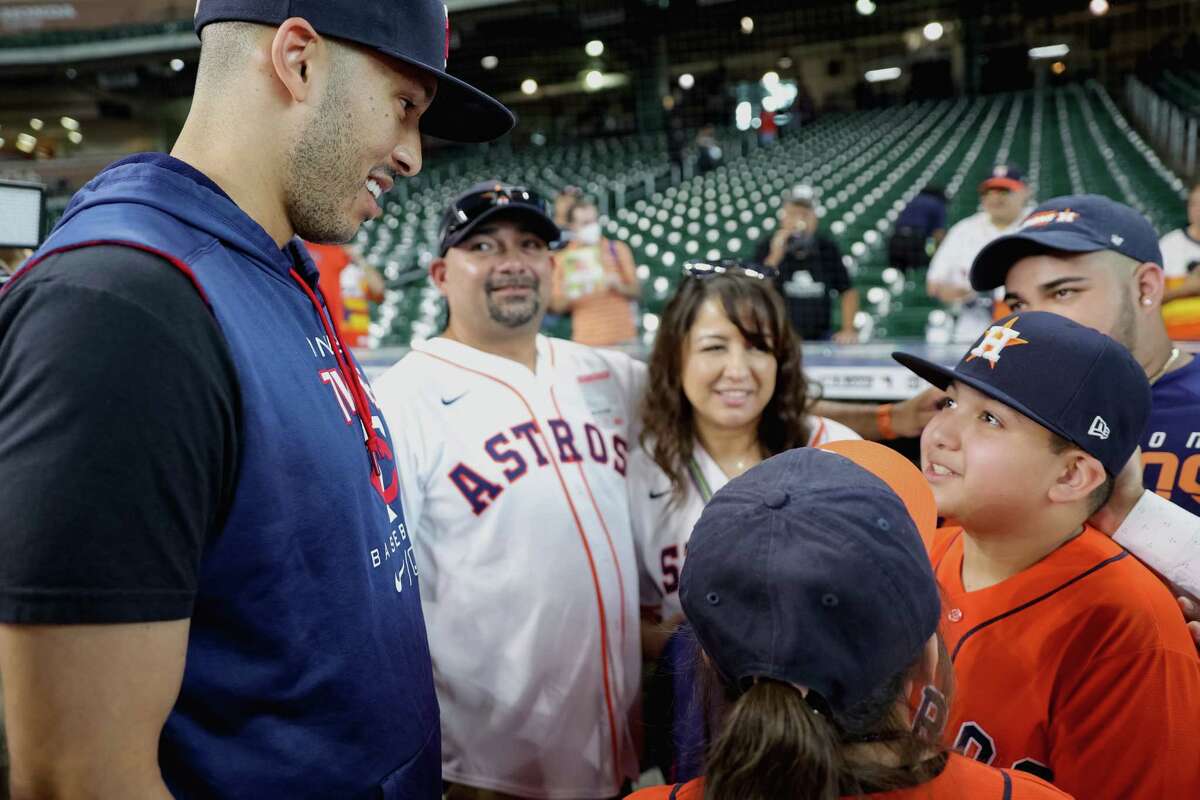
[{"xmin": 971, "ymin": 194, "xmax": 1200, "ymax": 643}]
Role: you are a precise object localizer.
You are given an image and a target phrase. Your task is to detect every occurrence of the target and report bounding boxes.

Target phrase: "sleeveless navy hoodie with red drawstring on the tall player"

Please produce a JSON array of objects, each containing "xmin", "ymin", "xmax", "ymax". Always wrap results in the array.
[{"xmin": 19, "ymin": 155, "xmax": 442, "ymax": 800}]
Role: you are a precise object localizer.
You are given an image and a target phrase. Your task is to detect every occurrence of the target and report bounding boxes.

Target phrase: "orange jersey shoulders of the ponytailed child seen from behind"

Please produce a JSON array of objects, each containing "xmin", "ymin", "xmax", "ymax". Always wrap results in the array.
[{"xmin": 626, "ymin": 754, "xmax": 1082, "ymax": 800}]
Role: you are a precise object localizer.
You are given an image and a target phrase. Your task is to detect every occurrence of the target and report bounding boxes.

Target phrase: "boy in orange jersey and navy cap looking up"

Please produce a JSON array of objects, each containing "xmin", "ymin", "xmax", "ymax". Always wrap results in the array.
[{"xmin": 894, "ymin": 312, "xmax": 1200, "ymax": 800}]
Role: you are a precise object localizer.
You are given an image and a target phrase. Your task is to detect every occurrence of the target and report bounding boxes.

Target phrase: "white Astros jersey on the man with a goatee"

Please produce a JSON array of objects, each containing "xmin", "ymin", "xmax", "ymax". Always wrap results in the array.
[{"xmin": 376, "ymin": 336, "xmax": 646, "ymax": 800}]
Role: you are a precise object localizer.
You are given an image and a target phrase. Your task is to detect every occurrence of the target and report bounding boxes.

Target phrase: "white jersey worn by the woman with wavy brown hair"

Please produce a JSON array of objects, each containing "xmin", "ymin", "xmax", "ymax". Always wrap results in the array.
[{"xmin": 633, "ymin": 416, "xmax": 862, "ymax": 620}]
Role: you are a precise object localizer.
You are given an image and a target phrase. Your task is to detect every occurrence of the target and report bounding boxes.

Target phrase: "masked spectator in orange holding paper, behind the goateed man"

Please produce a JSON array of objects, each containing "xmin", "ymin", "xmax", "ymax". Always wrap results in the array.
[{"xmin": 551, "ymin": 200, "xmax": 642, "ymax": 347}]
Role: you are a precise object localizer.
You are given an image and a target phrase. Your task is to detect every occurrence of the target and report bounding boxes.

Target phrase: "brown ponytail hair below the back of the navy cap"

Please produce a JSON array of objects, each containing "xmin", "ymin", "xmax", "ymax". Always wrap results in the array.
[{"xmin": 700, "ymin": 637, "xmax": 953, "ymax": 800}]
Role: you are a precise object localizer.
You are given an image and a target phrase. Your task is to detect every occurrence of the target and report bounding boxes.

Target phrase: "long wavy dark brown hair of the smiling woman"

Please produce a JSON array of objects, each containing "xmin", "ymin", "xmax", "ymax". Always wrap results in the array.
[{"xmin": 641, "ymin": 273, "xmax": 810, "ymax": 499}]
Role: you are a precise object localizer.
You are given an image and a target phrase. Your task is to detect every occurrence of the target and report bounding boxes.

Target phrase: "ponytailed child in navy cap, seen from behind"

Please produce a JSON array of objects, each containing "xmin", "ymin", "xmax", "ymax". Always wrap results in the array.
[{"xmin": 630, "ymin": 441, "xmax": 1070, "ymax": 800}]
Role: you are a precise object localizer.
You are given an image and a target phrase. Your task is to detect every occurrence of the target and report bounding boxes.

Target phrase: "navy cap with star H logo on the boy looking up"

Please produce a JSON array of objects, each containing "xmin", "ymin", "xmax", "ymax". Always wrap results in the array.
[{"xmin": 892, "ymin": 311, "xmax": 1150, "ymax": 475}]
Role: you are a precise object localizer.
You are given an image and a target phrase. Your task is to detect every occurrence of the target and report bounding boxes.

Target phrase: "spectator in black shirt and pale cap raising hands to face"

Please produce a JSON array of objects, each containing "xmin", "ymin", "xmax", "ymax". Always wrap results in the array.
[{"xmin": 755, "ymin": 185, "xmax": 858, "ymax": 344}]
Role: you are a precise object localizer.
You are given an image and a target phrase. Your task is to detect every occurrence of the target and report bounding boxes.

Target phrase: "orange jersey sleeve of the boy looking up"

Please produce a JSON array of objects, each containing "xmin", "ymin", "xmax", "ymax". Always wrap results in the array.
[{"xmin": 1050, "ymin": 646, "xmax": 1200, "ymax": 800}]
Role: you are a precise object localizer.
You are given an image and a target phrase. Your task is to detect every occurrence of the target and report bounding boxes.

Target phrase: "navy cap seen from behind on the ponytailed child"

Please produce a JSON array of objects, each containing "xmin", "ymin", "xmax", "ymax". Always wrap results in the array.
[{"xmin": 679, "ymin": 443, "xmax": 941, "ymax": 712}]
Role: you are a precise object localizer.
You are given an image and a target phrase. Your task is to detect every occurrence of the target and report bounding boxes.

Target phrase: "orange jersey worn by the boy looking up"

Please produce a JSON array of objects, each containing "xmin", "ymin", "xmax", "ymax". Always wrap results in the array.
[{"xmin": 930, "ymin": 528, "xmax": 1200, "ymax": 800}]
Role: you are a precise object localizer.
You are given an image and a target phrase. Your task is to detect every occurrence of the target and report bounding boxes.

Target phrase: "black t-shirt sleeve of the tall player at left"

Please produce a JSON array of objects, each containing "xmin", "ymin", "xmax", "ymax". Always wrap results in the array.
[{"xmin": 0, "ymin": 246, "xmax": 241, "ymax": 624}]
